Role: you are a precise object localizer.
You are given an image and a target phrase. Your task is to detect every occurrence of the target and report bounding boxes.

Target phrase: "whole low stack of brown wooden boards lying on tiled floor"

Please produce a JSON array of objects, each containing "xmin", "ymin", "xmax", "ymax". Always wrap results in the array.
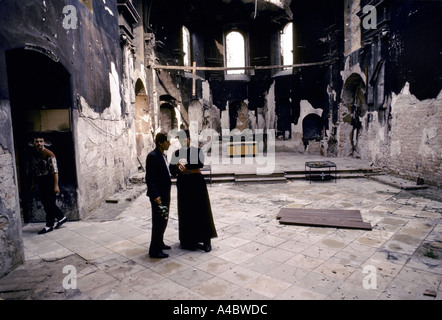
[{"xmin": 276, "ymin": 208, "xmax": 372, "ymax": 230}]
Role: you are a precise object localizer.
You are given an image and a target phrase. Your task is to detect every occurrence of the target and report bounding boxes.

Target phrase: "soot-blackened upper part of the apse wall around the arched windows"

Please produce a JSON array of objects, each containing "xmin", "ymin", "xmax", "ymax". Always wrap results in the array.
[{"xmin": 145, "ymin": 0, "xmax": 343, "ymax": 141}]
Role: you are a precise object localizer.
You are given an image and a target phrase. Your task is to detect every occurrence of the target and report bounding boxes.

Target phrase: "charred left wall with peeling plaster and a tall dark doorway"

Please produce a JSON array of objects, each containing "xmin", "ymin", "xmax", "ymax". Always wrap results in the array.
[{"xmin": 0, "ymin": 0, "xmax": 148, "ymax": 274}]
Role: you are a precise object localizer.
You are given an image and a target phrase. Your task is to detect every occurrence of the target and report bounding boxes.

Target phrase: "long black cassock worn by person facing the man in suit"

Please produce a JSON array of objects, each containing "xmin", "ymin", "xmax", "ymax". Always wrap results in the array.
[{"xmin": 169, "ymin": 147, "xmax": 217, "ymax": 246}]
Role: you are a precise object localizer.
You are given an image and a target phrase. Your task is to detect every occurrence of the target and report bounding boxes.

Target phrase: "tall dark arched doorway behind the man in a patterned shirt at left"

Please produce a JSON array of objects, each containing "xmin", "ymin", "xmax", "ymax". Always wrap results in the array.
[{"xmin": 6, "ymin": 48, "xmax": 78, "ymax": 223}]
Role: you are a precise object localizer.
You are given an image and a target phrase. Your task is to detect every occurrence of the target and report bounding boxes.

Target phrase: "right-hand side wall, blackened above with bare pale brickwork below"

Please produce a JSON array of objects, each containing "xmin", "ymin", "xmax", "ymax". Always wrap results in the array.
[{"xmin": 337, "ymin": 0, "xmax": 442, "ymax": 186}]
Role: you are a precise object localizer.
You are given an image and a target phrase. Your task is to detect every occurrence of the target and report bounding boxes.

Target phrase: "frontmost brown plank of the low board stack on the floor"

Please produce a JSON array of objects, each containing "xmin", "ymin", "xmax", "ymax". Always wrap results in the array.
[{"xmin": 279, "ymin": 217, "xmax": 372, "ymax": 230}]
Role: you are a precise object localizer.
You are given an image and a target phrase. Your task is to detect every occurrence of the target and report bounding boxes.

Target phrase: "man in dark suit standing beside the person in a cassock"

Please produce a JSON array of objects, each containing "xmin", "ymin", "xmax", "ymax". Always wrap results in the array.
[{"xmin": 146, "ymin": 132, "xmax": 172, "ymax": 258}]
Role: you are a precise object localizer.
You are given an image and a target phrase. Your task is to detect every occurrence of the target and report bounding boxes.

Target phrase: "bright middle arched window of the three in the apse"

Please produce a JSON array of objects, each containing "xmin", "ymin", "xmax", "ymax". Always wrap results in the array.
[{"xmin": 226, "ymin": 31, "xmax": 246, "ymax": 74}]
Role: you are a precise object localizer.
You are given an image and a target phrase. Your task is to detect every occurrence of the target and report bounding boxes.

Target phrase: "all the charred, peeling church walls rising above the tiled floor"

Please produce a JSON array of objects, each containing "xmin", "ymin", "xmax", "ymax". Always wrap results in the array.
[{"xmin": 0, "ymin": 0, "xmax": 442, "ymax": 274}]
